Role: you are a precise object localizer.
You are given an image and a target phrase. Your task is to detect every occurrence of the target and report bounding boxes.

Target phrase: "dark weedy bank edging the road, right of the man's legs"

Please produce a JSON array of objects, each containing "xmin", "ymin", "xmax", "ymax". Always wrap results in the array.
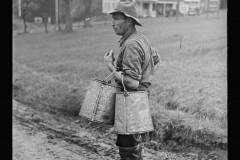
[{"xmin": 146, "ymin": 114, "xmax": 227, "ymax": 152}]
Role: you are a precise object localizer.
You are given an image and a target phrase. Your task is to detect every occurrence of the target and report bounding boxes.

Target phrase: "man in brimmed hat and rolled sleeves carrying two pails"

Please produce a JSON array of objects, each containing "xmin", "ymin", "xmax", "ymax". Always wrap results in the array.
[{"xmin": 104, "ymin": 0, "xmax": 160, "ymax": 160}]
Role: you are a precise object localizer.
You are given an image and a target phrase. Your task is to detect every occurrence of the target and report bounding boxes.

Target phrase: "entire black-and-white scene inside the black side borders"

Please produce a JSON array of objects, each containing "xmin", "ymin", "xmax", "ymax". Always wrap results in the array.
[{"xmin": 12, "ymin": 0, "xmax": 229, "ymax": 160}]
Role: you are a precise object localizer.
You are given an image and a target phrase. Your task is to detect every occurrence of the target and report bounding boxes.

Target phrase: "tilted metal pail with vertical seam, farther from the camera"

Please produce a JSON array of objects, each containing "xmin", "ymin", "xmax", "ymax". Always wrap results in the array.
[{"xmin": 79, "ymin": 74, "xmax": 122, "ymax": 125}]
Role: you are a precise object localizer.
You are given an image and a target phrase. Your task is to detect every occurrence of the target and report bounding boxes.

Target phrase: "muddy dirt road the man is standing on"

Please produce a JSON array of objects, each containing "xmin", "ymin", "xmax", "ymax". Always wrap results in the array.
[{"xmin": 13, "ymin": 100, "xmax": 221, "ymax": 160}]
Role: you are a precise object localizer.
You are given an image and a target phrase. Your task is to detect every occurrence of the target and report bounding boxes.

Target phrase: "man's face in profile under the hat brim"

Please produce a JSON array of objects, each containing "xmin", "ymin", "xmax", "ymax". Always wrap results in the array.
[{"xmin": 111, "ymin": 12, "xmax": 129, "ymax": 36}]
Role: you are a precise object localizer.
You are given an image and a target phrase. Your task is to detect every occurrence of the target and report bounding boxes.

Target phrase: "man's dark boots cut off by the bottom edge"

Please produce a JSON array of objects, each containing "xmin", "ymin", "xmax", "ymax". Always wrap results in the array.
[{"xmin": 119, "ymin": 144, "xmax": 143, "ymax": 160}]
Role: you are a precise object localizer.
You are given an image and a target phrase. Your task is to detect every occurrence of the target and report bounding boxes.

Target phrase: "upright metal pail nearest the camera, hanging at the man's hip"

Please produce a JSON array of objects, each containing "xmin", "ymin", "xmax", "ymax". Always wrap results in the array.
[{"xmin": 114, "ymin": 74, "xmax": 153, "ymax": 134}]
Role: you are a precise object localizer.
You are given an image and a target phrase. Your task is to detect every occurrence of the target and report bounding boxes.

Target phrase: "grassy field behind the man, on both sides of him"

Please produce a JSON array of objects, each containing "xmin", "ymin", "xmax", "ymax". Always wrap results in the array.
[{"xmin": 13, "ymin": 11, "xmax": 227, "ymax": 152}]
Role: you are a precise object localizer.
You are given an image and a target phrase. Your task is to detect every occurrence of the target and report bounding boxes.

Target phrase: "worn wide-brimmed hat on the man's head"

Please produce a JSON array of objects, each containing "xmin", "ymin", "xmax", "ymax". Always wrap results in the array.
[{"xmin": 107, "ymin": 0, "xmax": 142, "ymax": 26}]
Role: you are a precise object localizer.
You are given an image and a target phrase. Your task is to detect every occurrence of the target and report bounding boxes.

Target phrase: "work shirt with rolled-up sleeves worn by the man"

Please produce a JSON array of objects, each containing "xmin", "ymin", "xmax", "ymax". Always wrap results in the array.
[{"xmin": 116, "ymin": 28, "xmax": 160, "ymax": 90}]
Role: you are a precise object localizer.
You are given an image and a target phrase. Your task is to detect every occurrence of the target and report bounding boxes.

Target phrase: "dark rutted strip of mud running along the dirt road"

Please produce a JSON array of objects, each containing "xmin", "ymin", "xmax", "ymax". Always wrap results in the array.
[{"xmin": 14, "ymin": 116, "xmax": 118, "ymax": 160}]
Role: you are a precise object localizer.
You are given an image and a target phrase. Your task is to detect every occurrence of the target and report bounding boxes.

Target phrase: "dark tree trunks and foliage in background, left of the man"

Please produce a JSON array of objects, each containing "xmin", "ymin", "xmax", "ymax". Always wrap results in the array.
[{"xmin": 13, "ymin": 0, "xmax": 102, "ymax": 33}]
